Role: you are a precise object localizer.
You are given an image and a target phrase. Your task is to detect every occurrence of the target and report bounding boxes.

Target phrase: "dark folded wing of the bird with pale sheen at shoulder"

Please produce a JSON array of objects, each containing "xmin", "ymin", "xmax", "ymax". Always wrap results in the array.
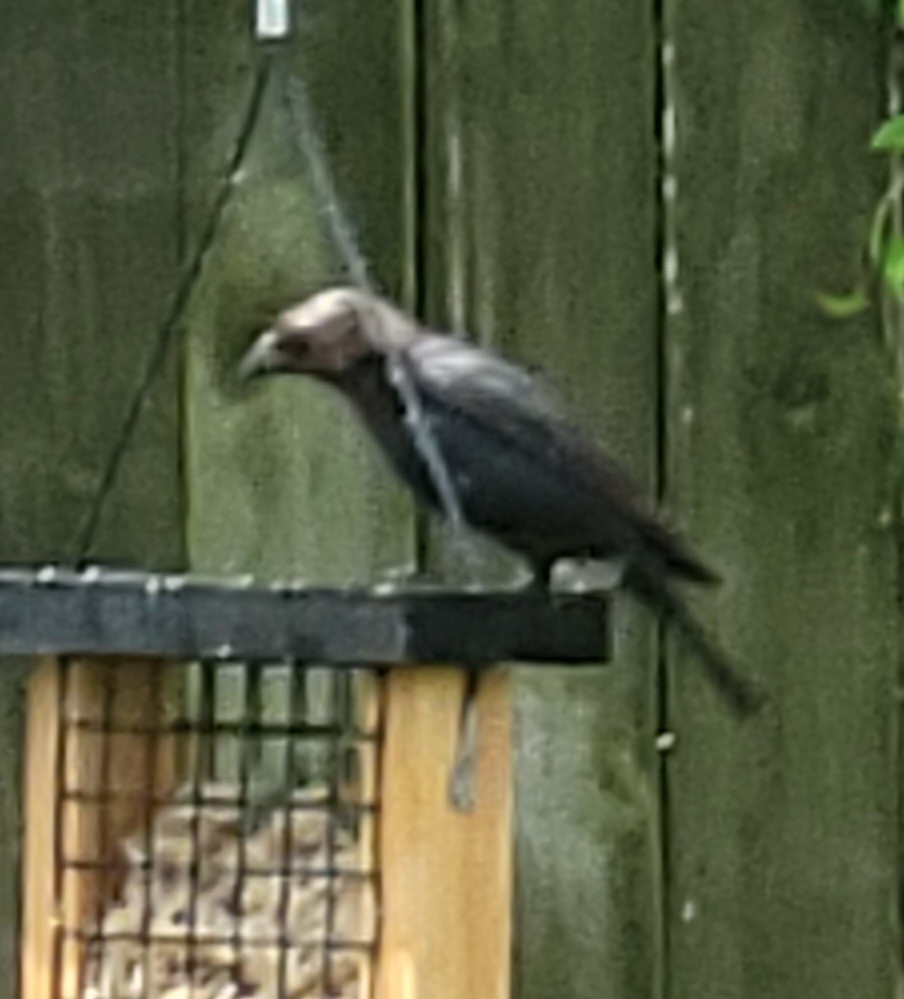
[{"xmin": 408, "ymin": 334, "xmax": 717, "ymax": 582}]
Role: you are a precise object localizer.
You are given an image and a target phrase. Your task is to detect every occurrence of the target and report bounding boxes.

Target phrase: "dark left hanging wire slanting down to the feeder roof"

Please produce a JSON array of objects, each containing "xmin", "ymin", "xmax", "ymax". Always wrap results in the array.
[{"xmin": 76, "ymin": 54, "xmax": 272, "ymax": 561}]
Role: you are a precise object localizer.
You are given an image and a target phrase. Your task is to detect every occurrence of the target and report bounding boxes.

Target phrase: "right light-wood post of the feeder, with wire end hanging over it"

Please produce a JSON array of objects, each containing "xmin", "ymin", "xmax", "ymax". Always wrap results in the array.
[{"xmin": 376, "ymin": 668, "xmax": 512, "ymax": 999}]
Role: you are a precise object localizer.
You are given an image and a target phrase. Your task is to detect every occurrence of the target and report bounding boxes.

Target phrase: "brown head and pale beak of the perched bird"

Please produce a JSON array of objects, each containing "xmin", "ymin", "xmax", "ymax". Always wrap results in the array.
[{"xmin": 239, "ymin": 288, "xmax": 418, "ymax": 381}]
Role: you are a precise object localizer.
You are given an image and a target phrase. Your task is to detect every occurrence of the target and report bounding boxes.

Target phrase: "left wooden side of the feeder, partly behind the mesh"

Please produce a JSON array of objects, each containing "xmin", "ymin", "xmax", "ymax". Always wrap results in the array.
[{"xmin": 21, "ymin": 657, "xmax": 177, "ymax": 999}]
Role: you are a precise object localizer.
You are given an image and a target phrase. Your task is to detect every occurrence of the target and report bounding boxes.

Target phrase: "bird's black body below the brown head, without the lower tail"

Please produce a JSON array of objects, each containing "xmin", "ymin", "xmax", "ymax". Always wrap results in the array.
[{"xmin": 336, "ymin": 334, "xmax": 716, "ymax": 582}]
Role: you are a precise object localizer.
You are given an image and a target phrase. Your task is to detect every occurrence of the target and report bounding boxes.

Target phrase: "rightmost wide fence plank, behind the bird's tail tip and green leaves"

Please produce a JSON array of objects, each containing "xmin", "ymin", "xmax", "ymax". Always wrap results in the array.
[{"xmin": 666, "ymin": 0, "xmax": 899, "ymax": 999}]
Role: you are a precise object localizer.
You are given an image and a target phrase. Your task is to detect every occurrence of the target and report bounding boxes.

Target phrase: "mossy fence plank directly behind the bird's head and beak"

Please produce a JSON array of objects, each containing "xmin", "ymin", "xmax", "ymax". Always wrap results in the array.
[{"xmin": 185, "ymin": 0, "xmax": 409, "ymax": 582}]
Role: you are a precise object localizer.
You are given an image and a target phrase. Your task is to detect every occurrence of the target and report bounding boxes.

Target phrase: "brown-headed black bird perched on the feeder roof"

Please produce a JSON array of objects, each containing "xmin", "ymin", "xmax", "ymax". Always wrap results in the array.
[{"xmin": 241, "ymin": 288, "xmax": 760, "ymax": 714}]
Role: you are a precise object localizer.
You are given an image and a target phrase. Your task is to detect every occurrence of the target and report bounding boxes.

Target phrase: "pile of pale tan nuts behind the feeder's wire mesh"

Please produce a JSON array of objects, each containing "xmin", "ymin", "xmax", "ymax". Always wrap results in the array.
[{"xmin": 82, "ymin": 785, "xmax": 374, "ymax": 999}]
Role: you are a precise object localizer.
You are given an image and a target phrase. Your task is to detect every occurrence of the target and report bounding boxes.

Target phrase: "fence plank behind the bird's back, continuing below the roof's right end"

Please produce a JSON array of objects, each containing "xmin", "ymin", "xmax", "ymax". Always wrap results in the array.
[{"xmin": 421, "ymin": 0, "xmax": 659, "ymax": 999}]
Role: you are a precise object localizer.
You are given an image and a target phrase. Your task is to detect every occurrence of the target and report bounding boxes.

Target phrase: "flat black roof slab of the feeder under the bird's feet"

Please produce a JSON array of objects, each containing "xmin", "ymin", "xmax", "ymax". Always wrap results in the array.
[{"xmin": 0, "ymin": 566, "xmax": 610, "ymax": 667}]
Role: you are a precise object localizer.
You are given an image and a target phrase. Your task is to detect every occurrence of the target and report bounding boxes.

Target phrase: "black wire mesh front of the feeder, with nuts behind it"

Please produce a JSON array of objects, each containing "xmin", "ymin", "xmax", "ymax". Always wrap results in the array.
[{"xmin": 32, "ymin": 659, "xmax": 380, "ymax": 999}]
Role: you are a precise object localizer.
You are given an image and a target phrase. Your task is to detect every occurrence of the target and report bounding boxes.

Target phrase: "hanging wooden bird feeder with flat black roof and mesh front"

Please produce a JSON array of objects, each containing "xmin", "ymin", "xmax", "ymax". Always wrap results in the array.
[{"xmin": 0, "ymin": 567, "xmax": 608, "ymax": 999}]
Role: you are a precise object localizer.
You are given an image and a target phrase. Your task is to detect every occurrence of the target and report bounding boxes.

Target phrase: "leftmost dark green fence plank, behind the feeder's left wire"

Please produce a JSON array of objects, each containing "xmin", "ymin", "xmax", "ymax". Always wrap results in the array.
[{"xmin": 0, "ymin": 0, "xmax": 182, "ymax": 995}]
